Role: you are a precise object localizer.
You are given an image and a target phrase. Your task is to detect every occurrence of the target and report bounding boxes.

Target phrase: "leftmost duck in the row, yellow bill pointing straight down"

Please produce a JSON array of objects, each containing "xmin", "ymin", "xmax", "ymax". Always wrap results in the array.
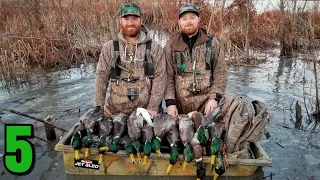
[{"xmin": 71, "ymin": 122, "xmax": 86, "ymax": 160}]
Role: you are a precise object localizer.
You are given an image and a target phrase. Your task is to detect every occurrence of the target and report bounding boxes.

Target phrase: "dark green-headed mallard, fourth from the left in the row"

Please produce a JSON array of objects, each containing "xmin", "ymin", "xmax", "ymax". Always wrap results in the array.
[{"xmin": 109, "ymin": 113, "xmax": 128, "ymax": 153}]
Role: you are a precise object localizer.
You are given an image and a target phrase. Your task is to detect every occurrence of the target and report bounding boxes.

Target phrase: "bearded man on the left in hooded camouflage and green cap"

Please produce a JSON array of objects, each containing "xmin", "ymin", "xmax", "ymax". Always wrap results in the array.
[{"xmin": 95, "ymin": 3, "xmax": 167, "ymax": 116}]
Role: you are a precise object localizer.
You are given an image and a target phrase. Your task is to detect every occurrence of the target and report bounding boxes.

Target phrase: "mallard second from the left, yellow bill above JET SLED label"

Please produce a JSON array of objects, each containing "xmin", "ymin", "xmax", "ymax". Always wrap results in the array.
[{"xmin": 80, "ymin": 106, "xmax": 104, "ymax": 158}]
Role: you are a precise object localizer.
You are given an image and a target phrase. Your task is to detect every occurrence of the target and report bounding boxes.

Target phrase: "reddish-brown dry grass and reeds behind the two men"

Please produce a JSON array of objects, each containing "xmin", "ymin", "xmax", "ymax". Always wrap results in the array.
[{"xmin": 0, "ymin": 0, "xmax": 320, "ymax": 80}]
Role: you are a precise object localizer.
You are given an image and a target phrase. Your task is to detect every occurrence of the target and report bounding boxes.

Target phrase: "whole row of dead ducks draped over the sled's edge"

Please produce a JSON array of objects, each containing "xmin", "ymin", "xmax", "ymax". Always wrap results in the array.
[{"xmin": 71, "ymin": 107, "xmax": 227, "ymax": 179}]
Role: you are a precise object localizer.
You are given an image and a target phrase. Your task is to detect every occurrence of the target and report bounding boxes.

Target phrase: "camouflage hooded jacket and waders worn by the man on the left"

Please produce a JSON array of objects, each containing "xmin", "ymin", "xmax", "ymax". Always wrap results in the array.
[{"xmin": 94, "ymin": 26, "xmax": 167, "ymax": 114}]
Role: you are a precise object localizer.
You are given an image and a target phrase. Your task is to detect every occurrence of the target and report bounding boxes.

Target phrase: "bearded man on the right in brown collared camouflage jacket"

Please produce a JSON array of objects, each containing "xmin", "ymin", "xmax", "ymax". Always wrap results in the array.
[{"xmin": 165, "ymin": 5, "xmax": 227, "ymax": 115}]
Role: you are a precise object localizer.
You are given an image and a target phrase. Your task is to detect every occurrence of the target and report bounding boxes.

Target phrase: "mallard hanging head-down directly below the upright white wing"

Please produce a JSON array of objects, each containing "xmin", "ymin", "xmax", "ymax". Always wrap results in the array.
[{"xmin": 141, "ymin": 124, "xmax": 153, "ymax": 166}]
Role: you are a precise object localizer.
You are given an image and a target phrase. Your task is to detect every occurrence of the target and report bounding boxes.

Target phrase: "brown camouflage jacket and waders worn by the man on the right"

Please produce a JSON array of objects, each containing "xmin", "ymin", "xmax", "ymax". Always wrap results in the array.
[{"xmin": 165, "ymin": 29, "xmax": 227, "ymax": 114}]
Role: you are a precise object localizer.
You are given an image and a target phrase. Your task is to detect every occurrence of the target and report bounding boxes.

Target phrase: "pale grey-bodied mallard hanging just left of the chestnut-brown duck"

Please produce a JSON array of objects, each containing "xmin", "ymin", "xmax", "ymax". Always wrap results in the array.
[{"xmin": 179, "ymin": 115, "xmax": 194, "ymax": 170}]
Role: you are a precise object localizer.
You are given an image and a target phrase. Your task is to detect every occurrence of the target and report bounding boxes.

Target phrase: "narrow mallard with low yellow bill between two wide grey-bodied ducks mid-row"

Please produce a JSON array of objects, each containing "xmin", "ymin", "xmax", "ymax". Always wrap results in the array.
[{"xmin": 167, "ymin": 124, "xmax": 179, "ymax": 174}]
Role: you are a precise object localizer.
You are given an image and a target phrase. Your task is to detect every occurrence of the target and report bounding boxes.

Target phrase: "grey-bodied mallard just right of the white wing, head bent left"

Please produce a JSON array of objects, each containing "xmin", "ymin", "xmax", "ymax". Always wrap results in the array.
[{"xmin": 151, "ymin": 114, "xmax": 179, "ymax": 157}]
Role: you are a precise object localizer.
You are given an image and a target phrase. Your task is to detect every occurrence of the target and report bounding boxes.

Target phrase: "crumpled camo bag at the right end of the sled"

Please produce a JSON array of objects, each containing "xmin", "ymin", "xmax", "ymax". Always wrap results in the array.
[{"xmin": 222, "ymin": 97, "xmax": 269, "ymax": 158}]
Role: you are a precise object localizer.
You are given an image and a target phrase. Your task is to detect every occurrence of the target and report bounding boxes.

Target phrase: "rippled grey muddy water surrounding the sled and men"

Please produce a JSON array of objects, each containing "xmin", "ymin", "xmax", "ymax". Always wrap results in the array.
[{"xmin": 0, "ymin": 50, "xmax": 320, "ymax": 180}]
